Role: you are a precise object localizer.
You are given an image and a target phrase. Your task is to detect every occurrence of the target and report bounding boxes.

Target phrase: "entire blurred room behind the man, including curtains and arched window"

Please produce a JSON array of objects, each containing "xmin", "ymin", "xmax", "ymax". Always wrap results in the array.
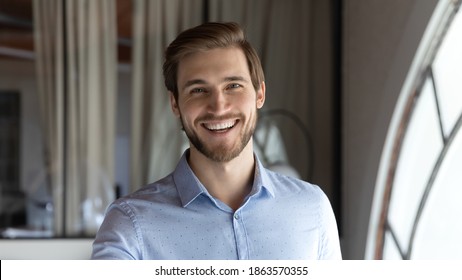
[{"xmin": 0, "ymin": 0, "xmax": 462, "ymax": 259}]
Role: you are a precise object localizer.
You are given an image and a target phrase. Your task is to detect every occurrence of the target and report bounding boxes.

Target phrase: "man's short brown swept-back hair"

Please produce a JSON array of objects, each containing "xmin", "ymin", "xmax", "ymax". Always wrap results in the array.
[{"xmin": 163, "ymin": 22, "xmax": 265, "ymax": 100}]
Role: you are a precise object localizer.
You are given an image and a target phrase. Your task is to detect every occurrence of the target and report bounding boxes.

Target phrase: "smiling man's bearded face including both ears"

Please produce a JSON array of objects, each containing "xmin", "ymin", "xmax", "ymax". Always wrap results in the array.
[{"xmin": 170, "ymin": 47, "xmax": 265, "ymax": 162}]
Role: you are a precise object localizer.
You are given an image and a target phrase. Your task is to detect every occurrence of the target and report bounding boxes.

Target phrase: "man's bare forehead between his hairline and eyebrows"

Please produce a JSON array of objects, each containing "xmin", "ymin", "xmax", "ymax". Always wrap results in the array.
[{"xmin": 178, "ymin": 47, "xmax": 250, "ymax": 87}]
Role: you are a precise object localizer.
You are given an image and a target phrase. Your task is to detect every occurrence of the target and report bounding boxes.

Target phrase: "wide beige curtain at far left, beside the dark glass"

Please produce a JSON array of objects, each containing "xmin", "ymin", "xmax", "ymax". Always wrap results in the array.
[{"xmin": 34, "ymin": 0, "xmax": 117, "ymax": 236}]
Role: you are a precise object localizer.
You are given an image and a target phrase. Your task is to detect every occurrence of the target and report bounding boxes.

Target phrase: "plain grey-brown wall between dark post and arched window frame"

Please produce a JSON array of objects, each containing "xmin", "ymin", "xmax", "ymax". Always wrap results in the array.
[{"xmin": 342, "ymin": 0, "xmax": 437, "ymax": 259}]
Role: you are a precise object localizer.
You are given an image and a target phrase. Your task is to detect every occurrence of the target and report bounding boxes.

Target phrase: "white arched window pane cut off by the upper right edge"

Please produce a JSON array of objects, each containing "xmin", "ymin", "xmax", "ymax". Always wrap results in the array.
[{"xmin": 433, "ymin": 12, "xmax": 462, "ymax": 136}]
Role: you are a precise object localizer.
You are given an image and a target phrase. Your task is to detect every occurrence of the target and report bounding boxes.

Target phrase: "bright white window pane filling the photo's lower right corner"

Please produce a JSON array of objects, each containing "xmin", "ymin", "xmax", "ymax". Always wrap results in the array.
[{"xmin": 412, "ymin": 123, "xmax": 462, "ymax": 259}]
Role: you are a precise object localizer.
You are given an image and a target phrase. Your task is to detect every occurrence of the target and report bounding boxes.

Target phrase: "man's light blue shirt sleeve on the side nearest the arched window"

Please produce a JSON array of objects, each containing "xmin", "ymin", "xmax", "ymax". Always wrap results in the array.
[{"xmin": 319, "ymin": 190, "xmax": 342, "ymax": 260}]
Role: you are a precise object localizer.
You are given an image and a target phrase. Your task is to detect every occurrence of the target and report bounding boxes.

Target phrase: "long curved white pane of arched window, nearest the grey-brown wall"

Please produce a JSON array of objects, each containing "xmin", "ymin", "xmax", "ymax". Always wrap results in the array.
[{"xmin": 388, "ymin": 79, "xmax": 443, "ymax": 248}]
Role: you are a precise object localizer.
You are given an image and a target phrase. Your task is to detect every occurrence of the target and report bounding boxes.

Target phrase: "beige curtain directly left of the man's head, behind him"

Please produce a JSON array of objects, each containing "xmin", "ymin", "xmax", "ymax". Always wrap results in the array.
[{"xmin": 130, "ymin": 0, "xmax": 203, "ymax": 191}]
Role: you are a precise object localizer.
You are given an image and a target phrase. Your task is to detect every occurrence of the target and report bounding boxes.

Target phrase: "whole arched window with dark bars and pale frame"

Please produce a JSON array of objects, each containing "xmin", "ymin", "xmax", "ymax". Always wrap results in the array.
[{"xmin": 368, "ymin": 1, "xmax": 462, "ymax": 259}]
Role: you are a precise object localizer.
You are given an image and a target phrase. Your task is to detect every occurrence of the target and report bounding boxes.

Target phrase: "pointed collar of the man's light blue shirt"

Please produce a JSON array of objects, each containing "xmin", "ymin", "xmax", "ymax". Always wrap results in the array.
[{"xmin": 173, "ymin": 149, "xmax": 274, "ymax": 207}]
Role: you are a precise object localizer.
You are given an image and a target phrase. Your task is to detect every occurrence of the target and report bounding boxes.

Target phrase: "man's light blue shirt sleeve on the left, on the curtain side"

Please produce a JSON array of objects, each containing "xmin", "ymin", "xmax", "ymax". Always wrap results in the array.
[{"xmin": 91, "ymin": 202, "xmax": 143, "ymax": 260}]
